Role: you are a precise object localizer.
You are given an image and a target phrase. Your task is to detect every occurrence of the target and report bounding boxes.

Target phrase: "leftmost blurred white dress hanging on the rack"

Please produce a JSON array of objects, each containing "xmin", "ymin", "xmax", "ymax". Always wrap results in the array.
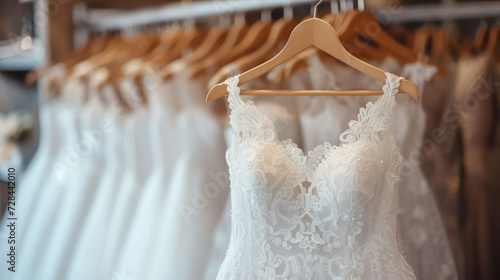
[{"xmin": 16, "ymin": 76, "xmax": 84, "ymax": 279}]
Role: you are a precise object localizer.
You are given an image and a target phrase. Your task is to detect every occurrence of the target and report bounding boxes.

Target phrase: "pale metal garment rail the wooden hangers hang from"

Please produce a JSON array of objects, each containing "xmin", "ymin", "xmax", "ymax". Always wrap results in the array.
[{"xmin": 87, "ymin": 0, "xmax": 500, "ymax": 32}]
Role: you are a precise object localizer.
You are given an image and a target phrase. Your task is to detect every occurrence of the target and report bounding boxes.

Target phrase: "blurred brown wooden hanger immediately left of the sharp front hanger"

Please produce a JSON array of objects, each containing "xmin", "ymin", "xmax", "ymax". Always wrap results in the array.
[{"xmin": 208, "ymin": 18, "xmax": 296, "ymax": 86}]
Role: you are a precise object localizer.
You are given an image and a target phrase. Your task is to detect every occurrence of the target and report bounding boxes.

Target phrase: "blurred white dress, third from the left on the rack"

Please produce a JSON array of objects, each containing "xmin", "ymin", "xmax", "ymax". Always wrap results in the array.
[{"xmin": 63, "ymin": 86, "xmax": 126, "ymax": 280}]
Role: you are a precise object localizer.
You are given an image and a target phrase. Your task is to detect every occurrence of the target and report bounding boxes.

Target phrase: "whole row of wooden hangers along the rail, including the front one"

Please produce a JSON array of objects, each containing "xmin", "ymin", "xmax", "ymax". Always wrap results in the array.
[{"xmin": 30, "ymin": 1, "xmax": 500, "ymax": 107}]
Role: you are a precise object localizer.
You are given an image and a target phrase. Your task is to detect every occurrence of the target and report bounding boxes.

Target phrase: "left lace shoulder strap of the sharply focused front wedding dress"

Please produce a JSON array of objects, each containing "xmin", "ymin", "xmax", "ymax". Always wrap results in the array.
[{"xmin": 224, "ymin": 75, "xmax": 275, "ymax": 140}]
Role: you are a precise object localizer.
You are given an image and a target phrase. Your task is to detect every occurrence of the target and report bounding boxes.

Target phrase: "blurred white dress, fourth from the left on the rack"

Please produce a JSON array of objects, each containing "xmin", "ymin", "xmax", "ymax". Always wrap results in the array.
[{"xmin": 99, "ymin": 80, "xmax": 152, "ymax": 279}]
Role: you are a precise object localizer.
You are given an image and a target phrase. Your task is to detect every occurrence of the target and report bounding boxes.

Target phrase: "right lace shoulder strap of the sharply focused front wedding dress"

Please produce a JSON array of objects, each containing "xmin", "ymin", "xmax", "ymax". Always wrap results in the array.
[{"xmin": 340, "ymin": 72, "xmax": 403, "ymax": 143}]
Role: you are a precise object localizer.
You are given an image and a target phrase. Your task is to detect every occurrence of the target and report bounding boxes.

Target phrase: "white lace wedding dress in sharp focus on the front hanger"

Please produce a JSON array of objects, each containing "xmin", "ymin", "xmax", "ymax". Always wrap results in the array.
[{"xmin": 217, "ymin": 73, "xmax": 415, "ymax": 280}]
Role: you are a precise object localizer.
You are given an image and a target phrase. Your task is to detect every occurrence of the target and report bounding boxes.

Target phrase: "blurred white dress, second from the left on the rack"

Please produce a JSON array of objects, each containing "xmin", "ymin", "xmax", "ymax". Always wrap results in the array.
[{"xmin": 38, "ymin": 83, "xmax": 109, "ymax": 280}]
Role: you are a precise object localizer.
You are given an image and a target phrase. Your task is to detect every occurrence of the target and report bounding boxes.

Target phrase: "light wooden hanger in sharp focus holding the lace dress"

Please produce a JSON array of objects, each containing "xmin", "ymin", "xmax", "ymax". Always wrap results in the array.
[{"xmin": 206, "ymin": 18, "xmax": 418, "ymax": 102}]
